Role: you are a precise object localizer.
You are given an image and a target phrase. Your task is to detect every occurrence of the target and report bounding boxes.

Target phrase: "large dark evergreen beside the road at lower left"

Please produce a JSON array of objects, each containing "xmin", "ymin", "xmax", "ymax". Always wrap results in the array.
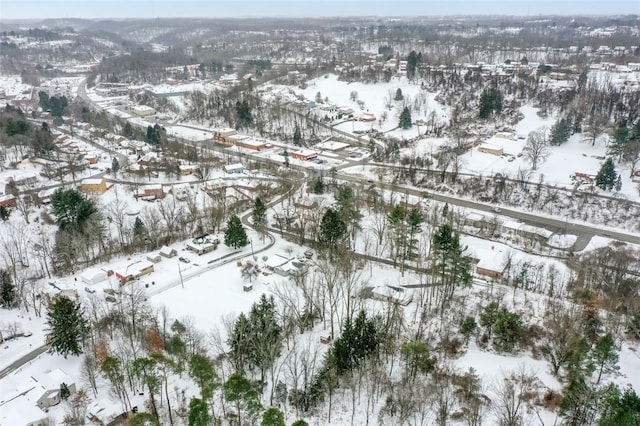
[{"xmin": 47, "ymin": 296, "xmax": 89, "ymax": 358}]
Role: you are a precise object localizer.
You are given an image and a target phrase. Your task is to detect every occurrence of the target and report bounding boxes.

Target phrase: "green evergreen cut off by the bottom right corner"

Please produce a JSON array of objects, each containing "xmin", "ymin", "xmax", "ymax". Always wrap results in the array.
[{"xmin": 598, "ymin": 383, "xmax": 640, "ymax": 426}]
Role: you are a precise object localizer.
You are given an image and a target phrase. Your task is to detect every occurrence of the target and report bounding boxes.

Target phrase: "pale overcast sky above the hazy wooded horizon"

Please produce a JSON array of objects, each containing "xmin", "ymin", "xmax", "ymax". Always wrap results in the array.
[{"xmin": 0, "ymin": 0, "xmax": 640, "ymax": 19}]
